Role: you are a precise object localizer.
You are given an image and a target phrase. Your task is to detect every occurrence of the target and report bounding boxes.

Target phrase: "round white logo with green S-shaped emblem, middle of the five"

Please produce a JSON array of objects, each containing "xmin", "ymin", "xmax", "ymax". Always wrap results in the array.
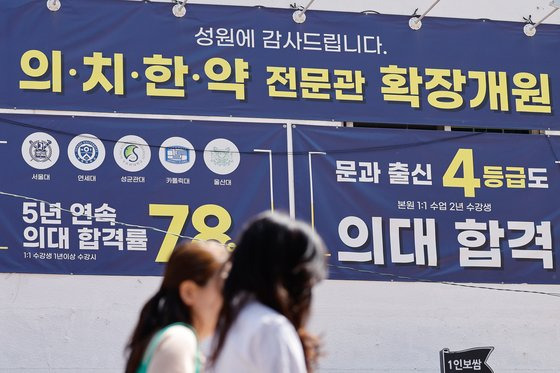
[{"xmin": 113, "ymin": 135, "xmax": 151, "ymax": 172}]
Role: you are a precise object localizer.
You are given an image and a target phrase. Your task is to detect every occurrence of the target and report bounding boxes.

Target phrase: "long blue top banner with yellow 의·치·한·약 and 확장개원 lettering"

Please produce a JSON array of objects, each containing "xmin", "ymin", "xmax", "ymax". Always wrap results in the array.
[{"xmin": 0, "ymin": 0, "xmax": 560, "ymax": 129}]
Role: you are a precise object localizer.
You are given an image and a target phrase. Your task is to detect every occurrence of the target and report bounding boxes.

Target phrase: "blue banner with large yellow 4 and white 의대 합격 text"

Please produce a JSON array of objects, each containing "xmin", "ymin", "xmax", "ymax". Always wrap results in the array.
[{"xmin": 294, "ymin": 126, "xmax": 560, "ymax": 284}]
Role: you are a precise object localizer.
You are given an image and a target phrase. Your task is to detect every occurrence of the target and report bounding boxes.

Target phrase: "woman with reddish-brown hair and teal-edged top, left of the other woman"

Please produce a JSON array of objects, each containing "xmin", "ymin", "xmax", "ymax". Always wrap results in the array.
[{"xmin": 126, "ymin": 241, "xmax": 228, "ymax": 373}]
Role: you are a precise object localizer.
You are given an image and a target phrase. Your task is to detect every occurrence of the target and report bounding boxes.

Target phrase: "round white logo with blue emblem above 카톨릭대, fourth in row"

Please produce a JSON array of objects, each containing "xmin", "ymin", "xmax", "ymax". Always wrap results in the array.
[{"xmin": 159, "ymin": 137, "xmax": 196, "ymax": 174}]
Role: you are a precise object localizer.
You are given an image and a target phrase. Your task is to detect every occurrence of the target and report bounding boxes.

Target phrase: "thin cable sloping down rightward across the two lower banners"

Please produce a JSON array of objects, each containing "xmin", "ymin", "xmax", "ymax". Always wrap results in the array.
[{"xmin": 0, "ymin": 191, "xmax": 560, "ymax": 297}]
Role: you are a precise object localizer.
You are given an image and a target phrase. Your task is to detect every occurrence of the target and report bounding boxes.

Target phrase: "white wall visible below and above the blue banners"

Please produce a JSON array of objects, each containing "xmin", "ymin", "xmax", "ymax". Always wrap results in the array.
[{"xmin": 0, "ymin": 0, "xmax": 560, "ymax": 373}]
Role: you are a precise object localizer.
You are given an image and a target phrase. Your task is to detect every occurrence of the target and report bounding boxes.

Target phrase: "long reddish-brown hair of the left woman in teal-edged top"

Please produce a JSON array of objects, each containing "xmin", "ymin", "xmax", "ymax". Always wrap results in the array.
[{"xmin": 125, "ymin": 241, "xmax": 222, "ymax": 373}]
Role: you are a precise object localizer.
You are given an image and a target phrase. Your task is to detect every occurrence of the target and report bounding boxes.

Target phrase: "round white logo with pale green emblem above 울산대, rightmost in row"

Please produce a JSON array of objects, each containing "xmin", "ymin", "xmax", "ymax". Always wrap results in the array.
[{"xmin": 204, "ymin": 139, "xmax": 241, "ymax": 175}]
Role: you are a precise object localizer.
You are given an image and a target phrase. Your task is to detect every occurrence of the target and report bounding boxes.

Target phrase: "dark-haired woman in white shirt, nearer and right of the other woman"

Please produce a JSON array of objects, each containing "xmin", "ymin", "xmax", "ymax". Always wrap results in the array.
[{"xmin": 207, "ymin": 212, "xmax": 326, "ymax": 373}]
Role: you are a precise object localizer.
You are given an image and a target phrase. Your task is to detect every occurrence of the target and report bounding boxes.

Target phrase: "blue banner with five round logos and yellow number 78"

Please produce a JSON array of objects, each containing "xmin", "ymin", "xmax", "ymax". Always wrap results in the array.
[{"xmin": 0, "ymin": 116, "xmax": 288, "ymax": 275}]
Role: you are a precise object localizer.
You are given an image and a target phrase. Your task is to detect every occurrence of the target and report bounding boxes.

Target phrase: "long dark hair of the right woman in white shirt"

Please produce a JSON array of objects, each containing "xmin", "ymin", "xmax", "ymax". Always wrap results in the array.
[{"xmin": 210, "ymin": 212, "xmax": 326, "ymax": 370}]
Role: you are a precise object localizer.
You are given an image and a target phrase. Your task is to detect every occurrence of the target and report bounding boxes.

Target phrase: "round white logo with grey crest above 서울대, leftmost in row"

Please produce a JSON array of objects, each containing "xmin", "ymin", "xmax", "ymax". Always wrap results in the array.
[{"xmin": 21, "ymin": 132, "xmax": 60, "ymax": 170}]
